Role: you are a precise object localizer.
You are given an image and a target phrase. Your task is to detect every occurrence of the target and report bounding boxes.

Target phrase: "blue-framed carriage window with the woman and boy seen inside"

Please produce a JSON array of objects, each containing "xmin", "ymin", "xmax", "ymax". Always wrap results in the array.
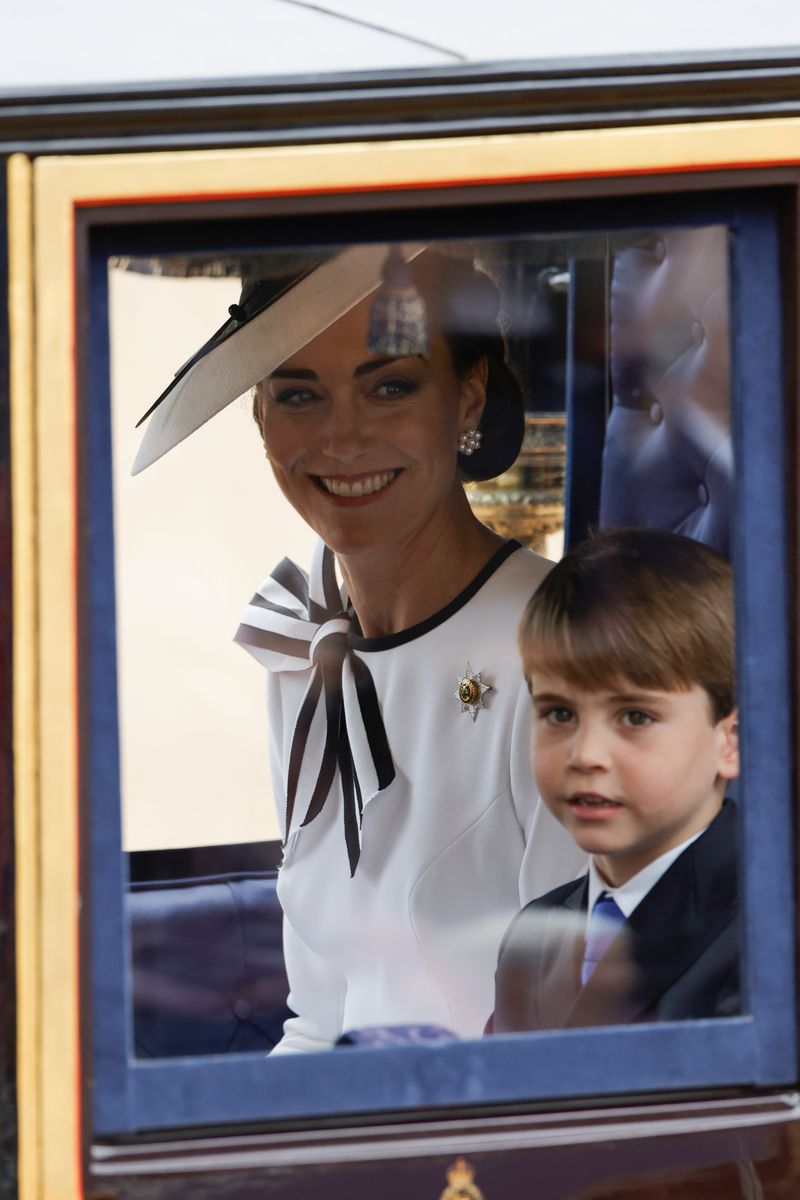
[{"xmin": 88, "ymin": 202, "xmax": 789, "ymax": 1134}]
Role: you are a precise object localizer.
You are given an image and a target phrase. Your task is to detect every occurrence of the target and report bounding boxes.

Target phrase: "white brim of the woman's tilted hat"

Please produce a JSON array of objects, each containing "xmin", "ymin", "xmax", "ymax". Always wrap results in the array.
[{"xmin": 131, "ymin": 244, "xmax": 425, "ymax": 475}]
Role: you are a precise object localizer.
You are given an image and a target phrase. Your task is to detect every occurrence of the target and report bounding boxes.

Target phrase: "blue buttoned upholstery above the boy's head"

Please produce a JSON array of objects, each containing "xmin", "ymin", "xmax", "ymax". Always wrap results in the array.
[{"xmin": 600, "ymin": 226, "xmax": 733, "ymax": 556}]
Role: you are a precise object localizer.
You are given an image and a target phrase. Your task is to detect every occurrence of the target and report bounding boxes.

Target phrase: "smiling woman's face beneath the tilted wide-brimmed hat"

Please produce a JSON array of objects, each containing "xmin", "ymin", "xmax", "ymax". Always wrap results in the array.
[{"xmin": 258, "ymin": 299, "xmax": 486, "ymax": 554}]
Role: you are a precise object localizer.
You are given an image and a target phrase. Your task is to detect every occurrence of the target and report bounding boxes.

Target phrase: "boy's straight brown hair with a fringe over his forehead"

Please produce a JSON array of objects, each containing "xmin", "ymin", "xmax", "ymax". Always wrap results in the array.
[{"xmin": 519, "ymin": 528, "xmax": 735, "ymax": 724}]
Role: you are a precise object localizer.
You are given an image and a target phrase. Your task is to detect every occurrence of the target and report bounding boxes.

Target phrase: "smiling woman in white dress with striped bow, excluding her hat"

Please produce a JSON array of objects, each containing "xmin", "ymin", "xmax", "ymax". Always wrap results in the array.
[{"xmin": 137, "ymin": 243, "xmax": 582, "ymax": 1051}]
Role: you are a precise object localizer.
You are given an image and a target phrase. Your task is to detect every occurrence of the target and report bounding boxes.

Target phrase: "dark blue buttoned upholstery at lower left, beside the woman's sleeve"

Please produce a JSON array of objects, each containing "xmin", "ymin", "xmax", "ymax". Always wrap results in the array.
[{"xmin": 127, "ymin": 871, "xmax": 290, "ymax": 1058}]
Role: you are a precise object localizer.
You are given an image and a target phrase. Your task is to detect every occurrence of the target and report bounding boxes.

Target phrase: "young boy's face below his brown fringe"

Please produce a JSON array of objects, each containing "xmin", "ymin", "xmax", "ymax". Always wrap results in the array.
[{"xmin": 525, "ymin": 662, "xmax": 739, "ymax": 887}]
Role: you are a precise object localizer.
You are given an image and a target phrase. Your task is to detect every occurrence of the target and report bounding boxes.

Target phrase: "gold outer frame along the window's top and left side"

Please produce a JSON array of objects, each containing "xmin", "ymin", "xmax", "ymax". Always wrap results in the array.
[{"xmin": 8, "ymin": 118, "xmax": 800, "ymax": 1200}]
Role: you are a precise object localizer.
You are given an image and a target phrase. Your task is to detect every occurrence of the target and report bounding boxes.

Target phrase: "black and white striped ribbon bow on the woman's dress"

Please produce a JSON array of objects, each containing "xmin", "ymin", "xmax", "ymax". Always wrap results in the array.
[{"xmin": 235, "ymin": 542, "xmax": 395, "ymax": 876}]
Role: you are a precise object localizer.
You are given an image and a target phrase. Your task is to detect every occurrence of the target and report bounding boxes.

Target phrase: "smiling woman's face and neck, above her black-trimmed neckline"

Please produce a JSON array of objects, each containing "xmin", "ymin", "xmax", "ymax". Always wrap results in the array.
[{"xmin": 255, "ymin": 254, "xmax": 501, "ymax": 636}]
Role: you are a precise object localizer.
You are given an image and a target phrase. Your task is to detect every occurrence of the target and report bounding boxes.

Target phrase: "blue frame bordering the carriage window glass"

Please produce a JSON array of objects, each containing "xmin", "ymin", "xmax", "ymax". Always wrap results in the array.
[{"xmin": 80, "ymin": 190, "xmax": 798, "ymax": 1138}]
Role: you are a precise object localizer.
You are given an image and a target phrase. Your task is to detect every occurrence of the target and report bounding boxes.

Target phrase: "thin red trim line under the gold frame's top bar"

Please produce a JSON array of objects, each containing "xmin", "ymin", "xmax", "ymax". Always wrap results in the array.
[{"xmin": 74, "ymin": 156, "xmax": 800, "ymax": 209}]
